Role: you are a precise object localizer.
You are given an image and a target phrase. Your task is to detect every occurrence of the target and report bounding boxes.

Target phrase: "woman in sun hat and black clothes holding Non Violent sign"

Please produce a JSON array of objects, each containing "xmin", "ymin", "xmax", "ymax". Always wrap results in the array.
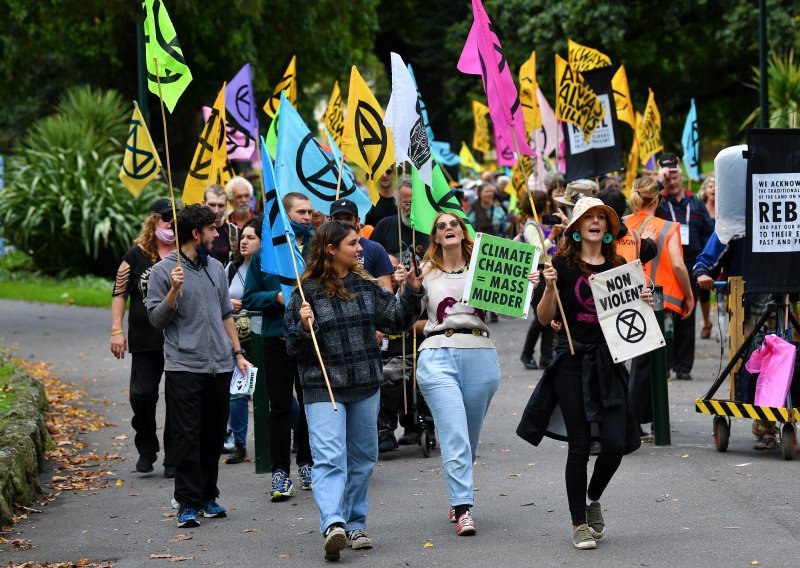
[{"xmin": 517, "ymin": 197, "xmax": 652, "ymax": 549}]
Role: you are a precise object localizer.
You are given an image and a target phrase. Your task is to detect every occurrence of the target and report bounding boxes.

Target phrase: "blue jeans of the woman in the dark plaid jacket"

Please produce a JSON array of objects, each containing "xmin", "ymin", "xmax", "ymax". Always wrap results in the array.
[{"xmin": 305, "ymin": 390, "xmax": 380, "ymax": 532}]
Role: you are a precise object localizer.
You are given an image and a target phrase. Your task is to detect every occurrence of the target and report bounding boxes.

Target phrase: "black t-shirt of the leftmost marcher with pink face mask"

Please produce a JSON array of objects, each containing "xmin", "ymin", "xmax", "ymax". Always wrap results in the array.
[{"xmin": 122, "ymin": 246, "xmax": 164, "ymax": 353}]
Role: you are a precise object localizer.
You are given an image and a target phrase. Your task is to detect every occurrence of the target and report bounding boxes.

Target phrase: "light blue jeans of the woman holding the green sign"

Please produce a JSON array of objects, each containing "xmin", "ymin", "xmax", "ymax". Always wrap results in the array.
[{"xmin": 417, "ymin": 347, "xmax": 500, "ymax": 507}]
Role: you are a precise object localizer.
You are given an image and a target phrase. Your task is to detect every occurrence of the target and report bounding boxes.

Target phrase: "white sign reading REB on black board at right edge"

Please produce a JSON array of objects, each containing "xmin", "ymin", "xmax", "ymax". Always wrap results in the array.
[{"xmin": 752, "ymin": 173, "xmax": 800, "ymax": 252}]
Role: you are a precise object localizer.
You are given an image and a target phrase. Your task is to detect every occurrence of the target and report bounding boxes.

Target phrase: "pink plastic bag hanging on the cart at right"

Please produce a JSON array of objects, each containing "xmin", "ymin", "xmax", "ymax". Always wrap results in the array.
[{"xmin": 745, "ymin": 334, "xmax": 797, "ymax": 408}]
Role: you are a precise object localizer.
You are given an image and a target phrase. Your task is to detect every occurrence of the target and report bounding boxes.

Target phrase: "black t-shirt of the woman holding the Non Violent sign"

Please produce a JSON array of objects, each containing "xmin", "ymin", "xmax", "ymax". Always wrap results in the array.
[{"xmin": 553, "ymin": 256, "xmax": 613, "ymax": 343}]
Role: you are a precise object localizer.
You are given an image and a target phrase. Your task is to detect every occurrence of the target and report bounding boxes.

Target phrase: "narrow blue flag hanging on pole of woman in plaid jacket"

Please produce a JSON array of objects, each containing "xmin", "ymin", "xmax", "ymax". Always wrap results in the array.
[{"xmin": 261, "ymin": 138, "xmax": 306, "ymax": 302}]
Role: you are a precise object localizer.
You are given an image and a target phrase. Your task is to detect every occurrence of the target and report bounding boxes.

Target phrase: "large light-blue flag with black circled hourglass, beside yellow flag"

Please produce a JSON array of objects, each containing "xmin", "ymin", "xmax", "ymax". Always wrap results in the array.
[{"xmin": 275, "ymin": 93, "xmax": 372, "ymax": 221}]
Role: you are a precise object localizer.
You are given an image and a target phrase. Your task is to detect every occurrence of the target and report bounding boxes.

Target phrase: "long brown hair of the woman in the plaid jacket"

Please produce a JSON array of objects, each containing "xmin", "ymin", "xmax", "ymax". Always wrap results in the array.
[{"xmin": 300, "ymin": 221, "xmax": 375, "ymax": 300}]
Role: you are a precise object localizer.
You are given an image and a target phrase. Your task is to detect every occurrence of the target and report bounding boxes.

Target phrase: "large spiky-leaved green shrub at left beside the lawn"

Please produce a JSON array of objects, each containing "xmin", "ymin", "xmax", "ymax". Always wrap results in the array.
[{"xmin": 0, "ymin": 87, "xmax": 166, "ymax": 275}]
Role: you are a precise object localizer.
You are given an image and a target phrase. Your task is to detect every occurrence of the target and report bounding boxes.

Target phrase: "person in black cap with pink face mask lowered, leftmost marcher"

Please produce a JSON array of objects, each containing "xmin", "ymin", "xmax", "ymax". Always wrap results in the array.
[{"xmin": 111, "ymin": 199, "xmax": 175, "ymax": 478}]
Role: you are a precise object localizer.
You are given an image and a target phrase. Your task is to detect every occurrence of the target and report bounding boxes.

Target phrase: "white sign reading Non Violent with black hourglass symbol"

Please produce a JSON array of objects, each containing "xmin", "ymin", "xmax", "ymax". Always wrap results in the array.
[{"xmin": 589, "ymin": 260, "xmax": 665, "ymax": 363}]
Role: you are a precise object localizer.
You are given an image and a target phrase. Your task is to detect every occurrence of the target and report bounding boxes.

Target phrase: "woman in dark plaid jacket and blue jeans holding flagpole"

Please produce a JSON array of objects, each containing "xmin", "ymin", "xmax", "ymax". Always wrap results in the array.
[{"xmin": 283, "ymin": 221, "xmax": 424, "ymax": 560}]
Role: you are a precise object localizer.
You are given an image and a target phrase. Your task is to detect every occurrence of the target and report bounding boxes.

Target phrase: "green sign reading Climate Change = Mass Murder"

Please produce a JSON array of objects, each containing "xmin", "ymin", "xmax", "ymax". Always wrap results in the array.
[{"xmin": 461, "ymin": 233, "xmax": 542, "ymax": 319}]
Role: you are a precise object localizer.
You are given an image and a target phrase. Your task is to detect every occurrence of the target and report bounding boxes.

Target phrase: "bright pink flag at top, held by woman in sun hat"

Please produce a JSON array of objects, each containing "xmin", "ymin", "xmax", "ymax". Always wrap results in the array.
[{"xmin": 458, "ymin": 0, "xmax": 536, "ymax": 158}]
